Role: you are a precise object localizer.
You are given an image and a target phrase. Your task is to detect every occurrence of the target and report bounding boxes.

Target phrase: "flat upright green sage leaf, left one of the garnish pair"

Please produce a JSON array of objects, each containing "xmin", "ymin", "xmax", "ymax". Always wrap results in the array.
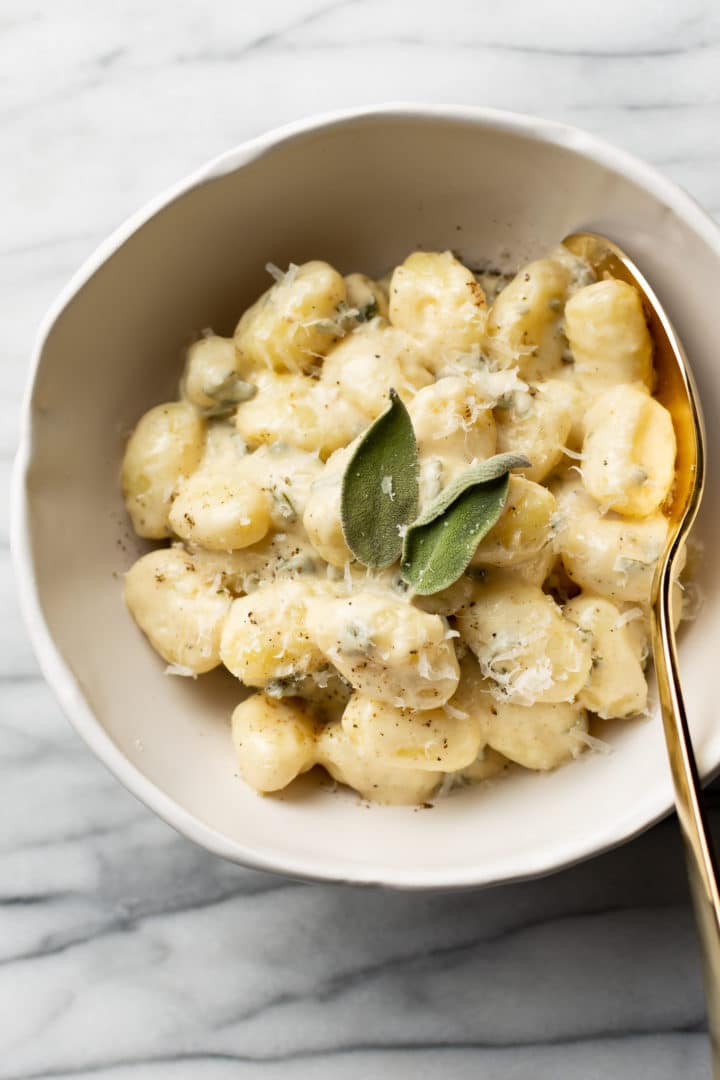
[{"xmin": 340, "ymin": 390, "xmax": 418, "ymax": 567}]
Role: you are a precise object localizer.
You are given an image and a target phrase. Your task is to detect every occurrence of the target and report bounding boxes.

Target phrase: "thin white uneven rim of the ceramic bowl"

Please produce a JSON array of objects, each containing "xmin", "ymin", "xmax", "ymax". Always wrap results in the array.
[{"xmin": 10, "ymin": 102, "xmax": 720, "ymax": 891}]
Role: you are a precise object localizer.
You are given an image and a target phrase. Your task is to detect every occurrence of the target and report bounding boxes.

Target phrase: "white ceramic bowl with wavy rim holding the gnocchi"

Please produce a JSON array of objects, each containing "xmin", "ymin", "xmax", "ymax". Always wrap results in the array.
[{"xmin": 13, "ymin": 105, "xmax": 720, "ymax": 888}]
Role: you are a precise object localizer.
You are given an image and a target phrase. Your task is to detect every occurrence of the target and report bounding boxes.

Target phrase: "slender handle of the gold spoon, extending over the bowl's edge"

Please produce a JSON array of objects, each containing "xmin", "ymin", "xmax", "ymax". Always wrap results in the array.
[{"xmin": 653, "ymin": 545, "xmax": 720, "ymax": 1080}]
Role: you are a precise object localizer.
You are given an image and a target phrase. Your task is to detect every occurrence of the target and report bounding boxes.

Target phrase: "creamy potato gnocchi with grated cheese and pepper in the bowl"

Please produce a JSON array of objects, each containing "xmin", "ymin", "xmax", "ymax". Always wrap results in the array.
[{"xmin": 122, "ymin": 248, "xmax": 676, "ymax": 804}]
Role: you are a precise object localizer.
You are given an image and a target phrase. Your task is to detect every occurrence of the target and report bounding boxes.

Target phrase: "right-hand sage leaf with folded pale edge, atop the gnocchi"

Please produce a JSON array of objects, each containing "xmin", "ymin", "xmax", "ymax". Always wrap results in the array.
[{"xmin": 400, "ymin": 454, "xmax": 530, "ymax": 596}]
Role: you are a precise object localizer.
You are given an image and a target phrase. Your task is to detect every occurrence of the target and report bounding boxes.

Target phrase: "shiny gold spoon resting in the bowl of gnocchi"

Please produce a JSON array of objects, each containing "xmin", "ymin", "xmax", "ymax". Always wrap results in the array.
[{"xmin": 562, "ymin": 232, "xmax": 720, "ymax": 1067}]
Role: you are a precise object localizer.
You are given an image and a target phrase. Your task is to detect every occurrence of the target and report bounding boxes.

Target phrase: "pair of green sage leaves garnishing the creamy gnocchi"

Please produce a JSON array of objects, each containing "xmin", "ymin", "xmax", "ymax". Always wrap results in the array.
[{"xmin": 341, "ymin": 390, "xmax": 531, "ymax": 596}]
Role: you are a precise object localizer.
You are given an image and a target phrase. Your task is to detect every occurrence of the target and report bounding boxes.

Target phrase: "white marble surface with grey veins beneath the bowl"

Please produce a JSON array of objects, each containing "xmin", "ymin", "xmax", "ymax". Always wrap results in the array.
[{"xmin": 0, "ymin": 0, "xmax": 720, "ymax": 1080}]
